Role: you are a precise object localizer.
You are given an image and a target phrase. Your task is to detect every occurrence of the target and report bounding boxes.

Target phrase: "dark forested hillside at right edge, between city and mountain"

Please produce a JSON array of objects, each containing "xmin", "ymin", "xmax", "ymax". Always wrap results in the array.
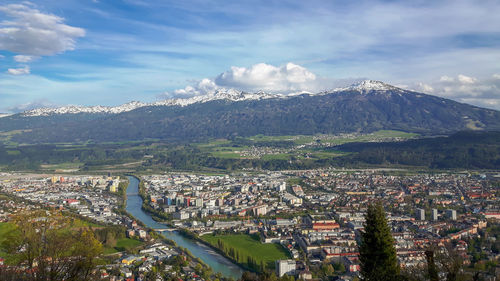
[{"xmin": 336, "ymin": 131, "xmax": 500, "ymax": 169}]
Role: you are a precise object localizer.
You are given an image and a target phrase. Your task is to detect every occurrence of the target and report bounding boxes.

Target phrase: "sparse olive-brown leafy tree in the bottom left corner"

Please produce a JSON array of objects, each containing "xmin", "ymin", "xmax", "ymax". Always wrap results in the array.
[{"xmin": 0, "ymin": 211, "xmax": 102, "ymax": 281}]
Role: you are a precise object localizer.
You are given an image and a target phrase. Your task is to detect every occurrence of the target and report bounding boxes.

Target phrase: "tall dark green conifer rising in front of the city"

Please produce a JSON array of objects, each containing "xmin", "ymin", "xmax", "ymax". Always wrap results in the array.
[{"xmin": 359, "ymin": 203, "xmax": 400, "ymax": 281}]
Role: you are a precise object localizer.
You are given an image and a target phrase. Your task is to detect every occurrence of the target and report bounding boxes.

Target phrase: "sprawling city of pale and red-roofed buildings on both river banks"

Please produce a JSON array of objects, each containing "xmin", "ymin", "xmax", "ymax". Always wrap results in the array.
[{"xmin": 0, "ymin": 169, "xmax": 500, "ymax": 280}]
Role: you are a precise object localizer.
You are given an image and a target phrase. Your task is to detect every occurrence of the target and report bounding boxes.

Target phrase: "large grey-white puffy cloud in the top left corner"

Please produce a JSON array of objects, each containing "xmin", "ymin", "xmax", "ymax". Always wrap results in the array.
[{"xmin": 0, "ymin": 4, "xmax": 85, "ymax": 56}]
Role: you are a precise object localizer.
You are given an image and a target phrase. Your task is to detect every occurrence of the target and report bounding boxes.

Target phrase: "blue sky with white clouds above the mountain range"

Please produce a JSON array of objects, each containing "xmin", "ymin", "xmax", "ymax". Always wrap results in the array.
[{"xmin": 0, "ymin": 0, "xmax": 500, "ymax": 113}]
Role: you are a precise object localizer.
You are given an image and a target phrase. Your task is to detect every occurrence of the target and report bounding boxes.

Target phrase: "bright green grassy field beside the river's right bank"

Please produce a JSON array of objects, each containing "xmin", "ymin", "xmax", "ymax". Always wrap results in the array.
[{"xmin": 201, "ymin": 234, "xmax": 289, "ymax": 268}]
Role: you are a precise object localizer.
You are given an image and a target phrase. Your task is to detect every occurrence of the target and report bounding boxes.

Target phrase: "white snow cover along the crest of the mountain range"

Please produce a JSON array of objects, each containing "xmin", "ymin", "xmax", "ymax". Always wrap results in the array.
[{"xmin": 22, "ymin": 80, "xmax": 404, "ymax": 117}]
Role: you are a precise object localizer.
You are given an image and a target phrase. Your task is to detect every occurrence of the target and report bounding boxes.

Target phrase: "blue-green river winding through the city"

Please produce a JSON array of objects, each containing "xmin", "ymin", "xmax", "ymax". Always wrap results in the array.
[{"xmin": 126, "ymin": 176, "xmax": 243, "ymax": 279}]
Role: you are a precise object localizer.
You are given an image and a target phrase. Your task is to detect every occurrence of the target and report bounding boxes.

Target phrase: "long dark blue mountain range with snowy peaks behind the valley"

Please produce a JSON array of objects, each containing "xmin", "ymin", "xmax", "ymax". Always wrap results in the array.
[{"xmin": 0, "ymin": 80, "xmax": 500, "ymax": 143}]
